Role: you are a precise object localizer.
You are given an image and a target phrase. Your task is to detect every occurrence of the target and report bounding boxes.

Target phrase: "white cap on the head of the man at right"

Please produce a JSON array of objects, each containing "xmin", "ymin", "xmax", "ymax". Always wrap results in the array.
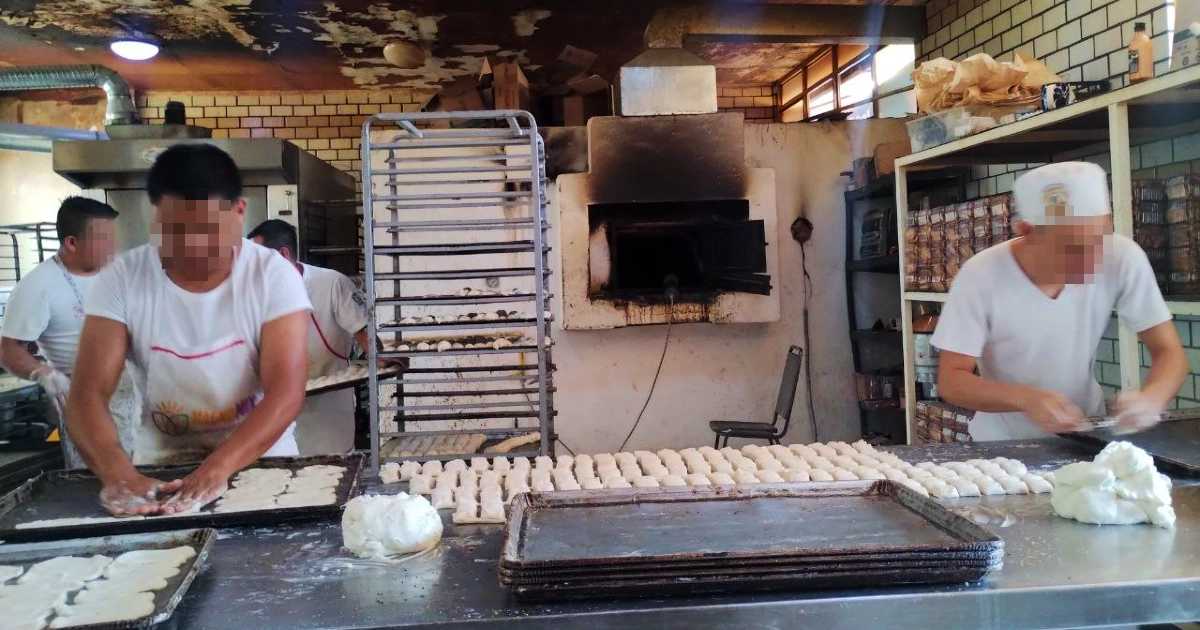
[{"xmin": 1013, "ymin": 162, "xmax": 1112, "ymax": 226}]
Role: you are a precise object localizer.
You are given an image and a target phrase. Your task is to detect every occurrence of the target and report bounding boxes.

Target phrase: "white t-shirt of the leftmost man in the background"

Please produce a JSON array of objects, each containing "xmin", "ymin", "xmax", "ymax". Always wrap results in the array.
[{"xmin": 0, "ymin": 259, "xmax": 96, "ymax": 376}]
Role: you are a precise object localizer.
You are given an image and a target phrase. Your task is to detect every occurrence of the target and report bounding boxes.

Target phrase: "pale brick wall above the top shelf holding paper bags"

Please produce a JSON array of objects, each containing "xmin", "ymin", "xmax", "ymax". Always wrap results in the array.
[{"xmin": 917, "ymin": 0, "xmax": 1177, "ymax": 88}]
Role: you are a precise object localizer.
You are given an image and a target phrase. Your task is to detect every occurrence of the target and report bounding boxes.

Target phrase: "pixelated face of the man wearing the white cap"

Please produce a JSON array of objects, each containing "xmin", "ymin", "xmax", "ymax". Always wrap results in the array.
[{"xmin": 1022, "ymin": 215, "xmax": 1112, "ymax": 284}]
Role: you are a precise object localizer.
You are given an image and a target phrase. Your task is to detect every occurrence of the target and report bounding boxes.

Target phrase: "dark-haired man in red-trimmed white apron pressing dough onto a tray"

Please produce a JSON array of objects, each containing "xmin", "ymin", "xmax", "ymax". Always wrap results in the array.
[{"xmin": 67, "ymin": 144, "xmax": 311, "ymax": 514}]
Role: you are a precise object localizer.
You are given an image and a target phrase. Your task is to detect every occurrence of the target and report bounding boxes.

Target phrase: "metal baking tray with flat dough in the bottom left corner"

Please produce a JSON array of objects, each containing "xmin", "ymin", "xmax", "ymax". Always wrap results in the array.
[{"xmin": 0, "ymin": 529, "xmax": 217, "ymax": 630}]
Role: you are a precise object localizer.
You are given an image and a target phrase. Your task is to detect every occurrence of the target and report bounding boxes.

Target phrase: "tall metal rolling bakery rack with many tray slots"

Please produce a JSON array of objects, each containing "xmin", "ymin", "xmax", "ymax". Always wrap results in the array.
[{"xmin": 362, "ymin": 110, "xmax": 554, "ymax": 468}]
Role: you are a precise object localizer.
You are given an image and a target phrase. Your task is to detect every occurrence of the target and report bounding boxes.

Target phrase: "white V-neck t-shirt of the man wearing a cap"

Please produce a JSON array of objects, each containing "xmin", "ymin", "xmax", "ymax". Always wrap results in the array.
[{"xmin": 932, "ymin": 235, "xmax": 1171, "ymax": 440}]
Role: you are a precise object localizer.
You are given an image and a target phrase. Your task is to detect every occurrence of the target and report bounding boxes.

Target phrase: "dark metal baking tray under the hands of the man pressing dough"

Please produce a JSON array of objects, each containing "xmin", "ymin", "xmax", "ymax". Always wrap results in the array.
[{"xmin": 0, "ymin": 454, "xmax": 366, "ymax": 542}]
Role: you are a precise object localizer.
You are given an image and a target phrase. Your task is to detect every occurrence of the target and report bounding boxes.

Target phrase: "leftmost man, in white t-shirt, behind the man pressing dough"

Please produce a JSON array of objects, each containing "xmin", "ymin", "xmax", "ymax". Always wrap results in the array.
[{"xmin": 0, "ymin": 197, "xmax": 142, "ymax": 469}]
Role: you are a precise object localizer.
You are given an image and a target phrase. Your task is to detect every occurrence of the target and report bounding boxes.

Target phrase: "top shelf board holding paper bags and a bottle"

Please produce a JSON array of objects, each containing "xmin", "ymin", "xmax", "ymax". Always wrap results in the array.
[{"xmin": 896, "ymin": 66, "xmax": 1200, "ymax": 168}]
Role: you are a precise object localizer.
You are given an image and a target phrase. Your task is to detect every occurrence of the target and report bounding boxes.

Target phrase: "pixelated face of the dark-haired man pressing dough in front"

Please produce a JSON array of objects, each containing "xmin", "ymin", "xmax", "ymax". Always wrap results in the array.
[{"xmin": 151, "ymin": 196, "xmax": 246, "ymax": 272}]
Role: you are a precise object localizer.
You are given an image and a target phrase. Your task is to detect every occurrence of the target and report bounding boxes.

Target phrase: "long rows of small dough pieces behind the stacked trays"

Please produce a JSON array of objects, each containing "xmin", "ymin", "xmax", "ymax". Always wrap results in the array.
[{"xmin": 380, "ymin": 443, "xmax": 1051, "ymax": 506}]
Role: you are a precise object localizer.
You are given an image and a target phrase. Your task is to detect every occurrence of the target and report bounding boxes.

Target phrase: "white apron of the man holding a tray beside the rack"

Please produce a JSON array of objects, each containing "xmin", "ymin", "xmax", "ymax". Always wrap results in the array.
[{"xmin": 296, "ymin": 304, "xmax": 355, "ymax": 456}]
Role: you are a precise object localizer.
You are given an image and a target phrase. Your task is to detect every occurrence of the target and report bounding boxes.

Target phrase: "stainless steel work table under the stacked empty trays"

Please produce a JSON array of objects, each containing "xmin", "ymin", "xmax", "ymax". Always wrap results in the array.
[{"xmin": 163, "ymin": 439, "xmax": 1200, "ymax": 630}]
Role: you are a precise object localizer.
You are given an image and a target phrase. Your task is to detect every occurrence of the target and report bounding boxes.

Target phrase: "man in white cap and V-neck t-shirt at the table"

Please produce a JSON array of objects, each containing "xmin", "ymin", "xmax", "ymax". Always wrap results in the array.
[{"xmin": 932, "ymin": 162, "xmax": 1188, "ymax": 440}]
